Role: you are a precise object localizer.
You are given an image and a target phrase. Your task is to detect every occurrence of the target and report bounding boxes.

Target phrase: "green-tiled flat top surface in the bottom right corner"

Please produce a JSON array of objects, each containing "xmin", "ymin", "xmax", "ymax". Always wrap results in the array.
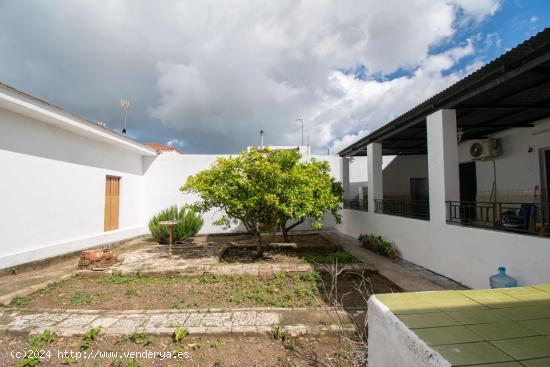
[{"xmin": 376, "ymin": 285, "xmax": 550, "ymax": 367}]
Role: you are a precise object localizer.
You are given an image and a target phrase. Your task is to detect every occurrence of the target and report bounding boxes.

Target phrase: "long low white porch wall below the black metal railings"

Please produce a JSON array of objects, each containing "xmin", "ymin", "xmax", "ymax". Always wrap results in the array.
[{"xmin": 338, "ymin": 209, "xmax": 550, "ymax": 288}]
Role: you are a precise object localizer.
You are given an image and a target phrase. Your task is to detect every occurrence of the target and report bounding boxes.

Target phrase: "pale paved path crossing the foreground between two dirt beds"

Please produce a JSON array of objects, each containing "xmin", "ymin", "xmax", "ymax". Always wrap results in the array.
[{"xmin": 0, "ymin": 308, "xmax": 365, "ymax": 336}]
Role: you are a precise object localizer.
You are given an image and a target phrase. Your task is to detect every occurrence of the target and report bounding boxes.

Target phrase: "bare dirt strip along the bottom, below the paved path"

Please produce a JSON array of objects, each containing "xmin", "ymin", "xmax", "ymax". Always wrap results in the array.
[{"xmin": 0, "ymin": 334, "xmax": 358, "ymax": 367}]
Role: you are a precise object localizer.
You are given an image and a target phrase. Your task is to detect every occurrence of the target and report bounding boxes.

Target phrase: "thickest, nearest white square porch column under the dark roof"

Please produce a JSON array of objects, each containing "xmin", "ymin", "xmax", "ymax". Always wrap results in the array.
[{"xmin": 426, "ymin": 110, "xmax": 460, "ymax": 224}]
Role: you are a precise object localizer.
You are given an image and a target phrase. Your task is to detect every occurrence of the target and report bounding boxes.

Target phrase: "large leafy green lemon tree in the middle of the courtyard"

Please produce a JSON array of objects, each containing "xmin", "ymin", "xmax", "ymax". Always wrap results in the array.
[{"xmin": 180, "ymin": 149, "xmax": 343, "ymax": 257}]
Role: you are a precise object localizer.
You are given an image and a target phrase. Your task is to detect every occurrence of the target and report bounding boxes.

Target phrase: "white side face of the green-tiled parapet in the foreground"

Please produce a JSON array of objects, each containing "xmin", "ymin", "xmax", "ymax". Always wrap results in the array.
[{"xmin": 368, "ymin": 296, "xmax": 451, "ymax": 367}]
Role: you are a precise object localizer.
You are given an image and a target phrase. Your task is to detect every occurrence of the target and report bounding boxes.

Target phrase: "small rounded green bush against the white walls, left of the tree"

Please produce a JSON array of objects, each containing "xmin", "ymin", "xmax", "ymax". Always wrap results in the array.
[{"xmin": 149, "ymin": 205, "xmax": 203, "ymax": 243}]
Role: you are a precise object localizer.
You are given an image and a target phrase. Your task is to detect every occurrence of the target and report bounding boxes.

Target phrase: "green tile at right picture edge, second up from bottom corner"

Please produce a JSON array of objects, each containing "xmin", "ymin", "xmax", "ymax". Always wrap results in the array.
[{"xmin": 492, "ymin": 335, "xmax": 550, "ymax": 360}]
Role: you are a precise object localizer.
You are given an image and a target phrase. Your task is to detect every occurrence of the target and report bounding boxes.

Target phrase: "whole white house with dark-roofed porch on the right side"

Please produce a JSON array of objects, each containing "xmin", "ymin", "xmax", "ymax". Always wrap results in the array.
[{"xmin": 340, "ymin": 30, "xmax": 550, "ymax": 288}]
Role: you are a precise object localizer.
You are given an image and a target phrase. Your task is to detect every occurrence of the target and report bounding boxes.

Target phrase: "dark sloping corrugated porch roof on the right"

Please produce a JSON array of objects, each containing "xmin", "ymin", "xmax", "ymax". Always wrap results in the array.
[{"xmin": 338, "ymin": 28, "xmax": 550, "ymax": 156}]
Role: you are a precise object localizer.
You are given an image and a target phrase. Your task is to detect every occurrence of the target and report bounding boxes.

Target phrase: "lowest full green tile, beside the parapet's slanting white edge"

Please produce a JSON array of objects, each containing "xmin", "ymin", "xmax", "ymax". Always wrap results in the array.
[{"xmin": 433, "ymin": 342, "xmax": 512, "ymax": 366}]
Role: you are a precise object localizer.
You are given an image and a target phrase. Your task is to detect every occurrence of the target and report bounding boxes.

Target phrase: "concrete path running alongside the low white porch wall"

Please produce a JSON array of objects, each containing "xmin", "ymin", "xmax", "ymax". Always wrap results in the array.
[{"xmin": 320, "ymin": 231, "xmax": 465, "ymax": 292}]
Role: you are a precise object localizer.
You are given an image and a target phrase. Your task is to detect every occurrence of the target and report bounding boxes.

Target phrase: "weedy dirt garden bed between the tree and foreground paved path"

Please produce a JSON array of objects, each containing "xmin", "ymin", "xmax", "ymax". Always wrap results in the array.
[{"xmin": 11, "ymin": 271, "xmax": 399, "ymax": 310}]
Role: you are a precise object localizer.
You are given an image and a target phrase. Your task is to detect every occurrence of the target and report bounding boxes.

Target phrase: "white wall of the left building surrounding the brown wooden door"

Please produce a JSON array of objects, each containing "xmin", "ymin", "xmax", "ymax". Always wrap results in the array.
[{"xmin": 0, "ymin": 109, "xmax": 149, "ymax": 268}]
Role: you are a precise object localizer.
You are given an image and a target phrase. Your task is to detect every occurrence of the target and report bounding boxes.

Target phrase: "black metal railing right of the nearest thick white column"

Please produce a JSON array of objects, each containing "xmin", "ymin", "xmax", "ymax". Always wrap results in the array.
[{"xmin": 446, "ymin": 201, "xmax": 550, "ymax": 237}]
